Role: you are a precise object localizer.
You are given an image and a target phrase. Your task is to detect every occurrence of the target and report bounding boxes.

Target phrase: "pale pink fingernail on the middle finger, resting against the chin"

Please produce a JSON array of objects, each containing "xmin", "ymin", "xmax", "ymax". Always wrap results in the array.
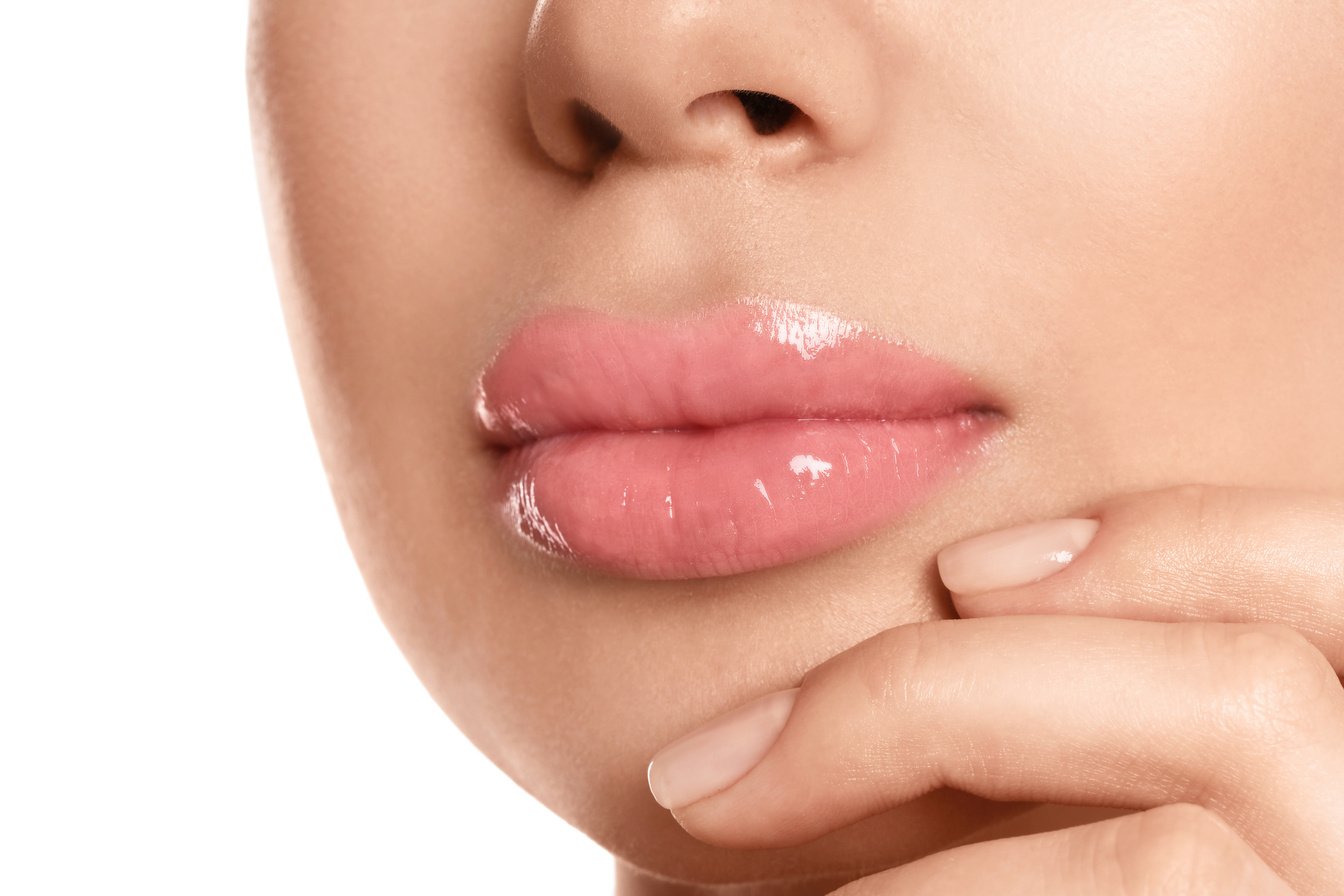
[{"xmin": 649, "ymin": 688, "xmax": 798, "ymax": 809}]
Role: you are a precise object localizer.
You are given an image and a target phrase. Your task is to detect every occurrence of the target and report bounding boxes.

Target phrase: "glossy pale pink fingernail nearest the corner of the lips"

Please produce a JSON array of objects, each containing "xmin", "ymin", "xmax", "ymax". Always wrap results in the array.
[{"xmin": 938, "ymin": 520, "xmax": 1101, "ymax": 594}]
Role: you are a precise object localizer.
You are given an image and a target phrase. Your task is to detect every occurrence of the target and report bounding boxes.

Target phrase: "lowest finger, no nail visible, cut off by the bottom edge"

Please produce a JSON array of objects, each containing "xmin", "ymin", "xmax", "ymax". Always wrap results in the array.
[{"xmin": 831, "ymin": 803, "xmax": 1293, "ymax": 896}]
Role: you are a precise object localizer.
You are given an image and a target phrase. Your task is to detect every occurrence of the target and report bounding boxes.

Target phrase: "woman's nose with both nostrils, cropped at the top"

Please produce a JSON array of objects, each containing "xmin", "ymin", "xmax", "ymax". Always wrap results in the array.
[{"xmin": 524, "ymin": 0, "xmax": 882, "ymax": 175}]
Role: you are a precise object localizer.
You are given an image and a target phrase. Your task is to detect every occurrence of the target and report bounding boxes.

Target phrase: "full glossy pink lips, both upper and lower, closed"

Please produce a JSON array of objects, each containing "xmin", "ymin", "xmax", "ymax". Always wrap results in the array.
[{"xmin": 476, "ymin": 301, "xmax": 1004, "ymax": 579}]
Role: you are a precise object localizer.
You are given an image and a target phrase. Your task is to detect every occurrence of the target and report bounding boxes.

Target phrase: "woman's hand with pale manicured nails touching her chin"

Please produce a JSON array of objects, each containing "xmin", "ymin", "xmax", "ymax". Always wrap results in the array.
[{"xmin": 649, "ymin": 486, "xmax": 1344, "ymax": 896}]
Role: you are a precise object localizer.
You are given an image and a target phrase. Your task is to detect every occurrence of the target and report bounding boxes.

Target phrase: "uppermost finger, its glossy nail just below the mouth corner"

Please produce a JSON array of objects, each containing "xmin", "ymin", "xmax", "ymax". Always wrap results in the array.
[{"xmin": 938, "ymin": 485, "xmax": 1344, "ymax": 673}]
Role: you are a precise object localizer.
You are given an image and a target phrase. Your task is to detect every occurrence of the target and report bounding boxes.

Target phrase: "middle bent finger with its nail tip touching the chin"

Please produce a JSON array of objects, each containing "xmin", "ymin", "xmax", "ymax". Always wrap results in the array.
[{"xmin": 649, "ymin": 617, "xmax": 1344, "ymax": 892}]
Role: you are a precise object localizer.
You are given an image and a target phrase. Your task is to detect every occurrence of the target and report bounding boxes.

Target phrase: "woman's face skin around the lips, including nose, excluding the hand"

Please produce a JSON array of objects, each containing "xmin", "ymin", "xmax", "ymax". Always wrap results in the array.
[{"xmin": 250, "ymin": 0, "xmax": 1344, "ymax": 881}]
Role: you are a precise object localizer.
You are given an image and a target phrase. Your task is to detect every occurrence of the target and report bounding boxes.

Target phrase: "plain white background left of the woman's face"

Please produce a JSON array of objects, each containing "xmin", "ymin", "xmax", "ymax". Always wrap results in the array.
[{"xmin": 0, "ymin": 0, "xmax": 612, "ymax": 896}]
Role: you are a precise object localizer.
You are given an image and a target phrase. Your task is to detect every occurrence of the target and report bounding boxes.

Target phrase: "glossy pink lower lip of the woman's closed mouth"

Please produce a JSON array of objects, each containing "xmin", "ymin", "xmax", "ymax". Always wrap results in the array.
[{"xmin": 501, "ymin": 411, "xmax": 1003, "ymax": 579}]
